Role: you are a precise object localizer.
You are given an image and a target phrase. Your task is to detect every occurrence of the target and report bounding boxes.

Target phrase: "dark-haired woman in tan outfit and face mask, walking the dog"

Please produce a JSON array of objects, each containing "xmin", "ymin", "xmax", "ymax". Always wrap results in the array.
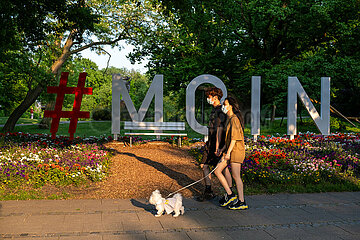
[{"xmin": 215, "ymin": 97, "xmax": 248, "ymax": 210}]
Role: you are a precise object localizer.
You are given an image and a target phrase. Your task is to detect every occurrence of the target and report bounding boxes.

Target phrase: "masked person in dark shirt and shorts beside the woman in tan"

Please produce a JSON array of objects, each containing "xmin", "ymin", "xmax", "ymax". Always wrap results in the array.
[{"xmin": 196, "ymin": 87, "xmax": 232, "ymax": 201}]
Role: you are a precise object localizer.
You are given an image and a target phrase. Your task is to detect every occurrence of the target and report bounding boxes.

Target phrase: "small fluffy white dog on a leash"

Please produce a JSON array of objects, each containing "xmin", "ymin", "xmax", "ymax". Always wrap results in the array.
[{"xmin": 149, "ymin": 190, "xmax": 185, "ymax": 217}]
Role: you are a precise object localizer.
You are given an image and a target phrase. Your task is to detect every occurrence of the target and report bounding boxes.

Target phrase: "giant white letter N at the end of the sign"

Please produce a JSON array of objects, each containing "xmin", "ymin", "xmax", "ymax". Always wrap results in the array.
[{"xmin": 287, "ymin": 77, "xmax": 330, "ymax": 139}]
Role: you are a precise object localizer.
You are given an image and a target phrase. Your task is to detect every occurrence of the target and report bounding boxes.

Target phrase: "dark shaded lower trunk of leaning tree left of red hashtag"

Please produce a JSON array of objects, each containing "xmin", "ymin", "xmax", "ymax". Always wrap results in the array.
[{"xmin": 2, "ymin": 85, "xmax": 43, "ymax": 132}]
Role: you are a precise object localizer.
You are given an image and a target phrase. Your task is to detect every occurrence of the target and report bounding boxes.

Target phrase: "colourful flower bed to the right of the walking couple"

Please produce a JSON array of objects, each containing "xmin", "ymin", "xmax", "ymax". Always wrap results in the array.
[{"xmin": 191, "ymin": 133, "xmax": 360, "ymax": 190}]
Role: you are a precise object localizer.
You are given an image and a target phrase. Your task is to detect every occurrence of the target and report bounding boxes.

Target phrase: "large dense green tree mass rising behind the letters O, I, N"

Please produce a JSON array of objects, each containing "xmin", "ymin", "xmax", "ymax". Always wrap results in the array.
[{"xmin": 132, "ymin": 0, "xmax": 360, "ymax": 114}]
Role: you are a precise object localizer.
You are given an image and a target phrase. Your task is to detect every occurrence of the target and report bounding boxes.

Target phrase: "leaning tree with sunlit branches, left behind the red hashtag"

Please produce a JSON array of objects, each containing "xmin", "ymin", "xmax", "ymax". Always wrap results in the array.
[{"xmin": 0, "ymin": 0, "xmax": 162, "ymax": 131}]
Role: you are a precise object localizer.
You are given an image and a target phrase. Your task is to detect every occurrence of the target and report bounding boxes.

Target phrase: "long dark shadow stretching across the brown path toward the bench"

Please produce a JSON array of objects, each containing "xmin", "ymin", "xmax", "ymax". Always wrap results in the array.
[{"xmin": 117, "ymin": 151, "xmax": 201, "ymax": 195}]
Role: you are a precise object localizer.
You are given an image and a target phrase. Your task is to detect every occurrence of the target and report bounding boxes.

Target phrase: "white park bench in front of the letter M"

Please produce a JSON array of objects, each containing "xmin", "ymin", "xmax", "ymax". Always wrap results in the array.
[{"xmin": 124, "ymin": 122, "xmax": 187, "ymax": 147}]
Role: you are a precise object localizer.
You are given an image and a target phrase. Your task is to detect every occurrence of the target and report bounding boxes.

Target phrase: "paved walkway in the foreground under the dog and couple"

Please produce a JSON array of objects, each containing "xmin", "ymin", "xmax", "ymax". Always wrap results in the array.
[{"xmin": 0, "ymin": 192, "xmax": 360, "ymax": 240}]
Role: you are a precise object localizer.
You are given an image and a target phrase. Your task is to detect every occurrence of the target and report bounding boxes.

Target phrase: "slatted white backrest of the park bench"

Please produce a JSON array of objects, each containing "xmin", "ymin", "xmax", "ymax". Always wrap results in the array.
[{"xmin": 124, "ymin": 122, "xmax": 185, "ymax": 131}]
